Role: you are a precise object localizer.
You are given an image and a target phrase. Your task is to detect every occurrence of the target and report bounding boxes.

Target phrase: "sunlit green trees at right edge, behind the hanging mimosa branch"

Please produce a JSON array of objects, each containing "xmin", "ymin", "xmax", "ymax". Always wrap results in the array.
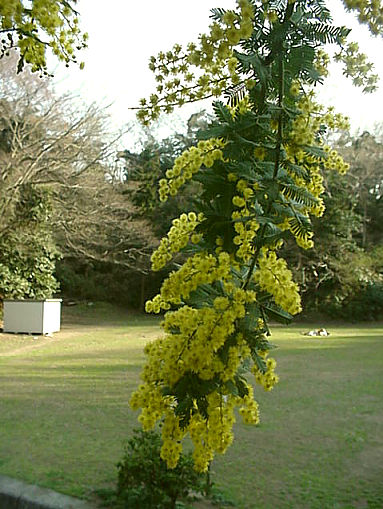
[{"xmin": 284, "ymin": 127, "xmax": 383, "ymax": 320}]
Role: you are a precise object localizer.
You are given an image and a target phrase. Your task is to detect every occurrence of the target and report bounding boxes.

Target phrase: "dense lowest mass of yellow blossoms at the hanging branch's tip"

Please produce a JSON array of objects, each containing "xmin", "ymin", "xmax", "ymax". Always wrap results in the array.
[{"xmin": 130, "ymin": 276, "xmax": 266, "ymax": 471}]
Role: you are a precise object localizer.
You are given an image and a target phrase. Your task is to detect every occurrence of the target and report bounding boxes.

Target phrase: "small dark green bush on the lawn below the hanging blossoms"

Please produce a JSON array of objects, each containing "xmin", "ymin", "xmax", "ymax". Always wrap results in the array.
[{"xmin": 117, "ymin": 430, "xmax": 205, "ymax": 509}]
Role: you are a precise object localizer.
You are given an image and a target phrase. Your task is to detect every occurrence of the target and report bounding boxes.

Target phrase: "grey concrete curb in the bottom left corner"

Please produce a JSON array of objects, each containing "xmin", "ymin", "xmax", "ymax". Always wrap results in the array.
[{"xmin": 0, "ymin": 475, "xmax": 96, "ymax": 509}]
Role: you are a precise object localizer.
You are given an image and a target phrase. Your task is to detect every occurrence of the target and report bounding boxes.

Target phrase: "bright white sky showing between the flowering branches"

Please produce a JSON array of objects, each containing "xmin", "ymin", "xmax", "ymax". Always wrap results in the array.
[{"xmin": 51, "ymin": 0, "xmax": 383, "ymax": 146}]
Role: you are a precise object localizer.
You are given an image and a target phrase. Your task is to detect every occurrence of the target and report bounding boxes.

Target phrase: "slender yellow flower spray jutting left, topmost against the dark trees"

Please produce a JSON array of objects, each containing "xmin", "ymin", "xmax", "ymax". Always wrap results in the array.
[{"xmin": 159, "ymin": 138, "xmax": 225, "ymax": 201}]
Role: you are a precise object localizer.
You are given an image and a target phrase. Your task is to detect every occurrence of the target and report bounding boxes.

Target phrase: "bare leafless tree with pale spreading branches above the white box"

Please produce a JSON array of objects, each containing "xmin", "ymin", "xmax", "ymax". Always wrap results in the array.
[{"xmin": 0, "ymin": 53, "xmax": 155, "ymax": 304}]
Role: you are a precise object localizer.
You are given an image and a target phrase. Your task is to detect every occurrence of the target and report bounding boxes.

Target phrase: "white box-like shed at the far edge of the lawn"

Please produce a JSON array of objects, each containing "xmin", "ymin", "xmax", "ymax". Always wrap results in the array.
[{"xmin": 3, "ymin": 299, "xmax": 61, "ymax": 334}]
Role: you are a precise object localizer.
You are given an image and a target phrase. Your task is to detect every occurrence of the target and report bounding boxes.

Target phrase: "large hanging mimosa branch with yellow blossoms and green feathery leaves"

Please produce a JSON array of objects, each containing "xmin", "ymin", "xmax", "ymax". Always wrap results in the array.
[{"xmin": 131, "ymin": 0, "xmax": 382, "ymax": 471}]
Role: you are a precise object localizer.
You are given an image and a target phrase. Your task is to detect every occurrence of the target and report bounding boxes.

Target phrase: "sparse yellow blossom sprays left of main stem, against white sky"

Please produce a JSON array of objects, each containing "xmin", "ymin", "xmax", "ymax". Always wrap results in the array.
[{"xmin": 137, "ymin": 0, "xmax": 254, "ymax": 124}]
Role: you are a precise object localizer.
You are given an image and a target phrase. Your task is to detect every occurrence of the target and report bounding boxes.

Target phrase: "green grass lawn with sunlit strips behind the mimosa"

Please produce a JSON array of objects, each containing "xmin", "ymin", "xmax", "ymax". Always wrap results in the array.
[{"xmin": 0, "ymin": 304, "xmax": 383, "ymax": 509}]
